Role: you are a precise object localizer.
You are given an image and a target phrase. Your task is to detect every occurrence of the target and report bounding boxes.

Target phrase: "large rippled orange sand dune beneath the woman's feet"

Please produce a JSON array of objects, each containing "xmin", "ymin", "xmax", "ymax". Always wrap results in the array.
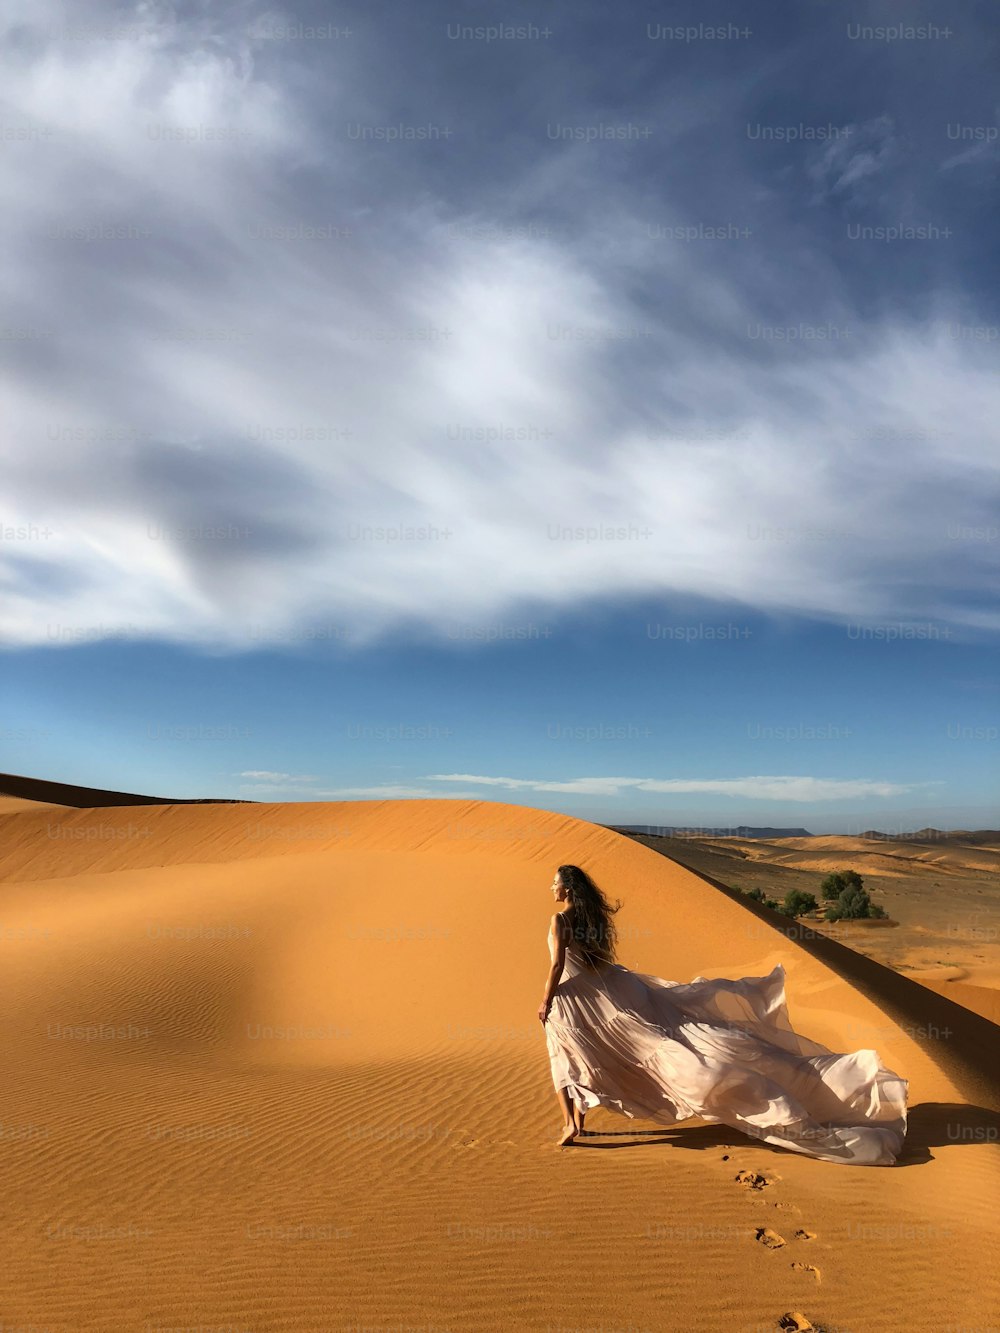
[{"xmin": 0, "ymin": 800, "xmax": 1000, "ymax": 1333}]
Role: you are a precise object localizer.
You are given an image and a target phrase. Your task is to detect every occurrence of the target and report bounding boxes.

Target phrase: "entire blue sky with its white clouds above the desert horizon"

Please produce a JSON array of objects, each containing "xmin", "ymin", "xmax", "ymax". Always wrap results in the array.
[{"xmin": 0, "ymin": 0, "xmax": 1000, "ymax": 832}]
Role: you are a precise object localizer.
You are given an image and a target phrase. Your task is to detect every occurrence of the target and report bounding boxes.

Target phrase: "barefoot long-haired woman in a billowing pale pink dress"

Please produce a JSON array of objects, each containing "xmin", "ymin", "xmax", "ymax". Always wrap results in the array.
[{"xmin": 539, "ymin": 865, "xmax": 908, "ymax": 1166}]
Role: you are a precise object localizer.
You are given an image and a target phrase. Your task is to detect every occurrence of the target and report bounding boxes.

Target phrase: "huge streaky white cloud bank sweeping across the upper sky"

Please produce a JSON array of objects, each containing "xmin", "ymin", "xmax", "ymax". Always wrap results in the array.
[{"xmin": 0, "ymin": 4, "xmax": 1000, "ymax": 651}]
